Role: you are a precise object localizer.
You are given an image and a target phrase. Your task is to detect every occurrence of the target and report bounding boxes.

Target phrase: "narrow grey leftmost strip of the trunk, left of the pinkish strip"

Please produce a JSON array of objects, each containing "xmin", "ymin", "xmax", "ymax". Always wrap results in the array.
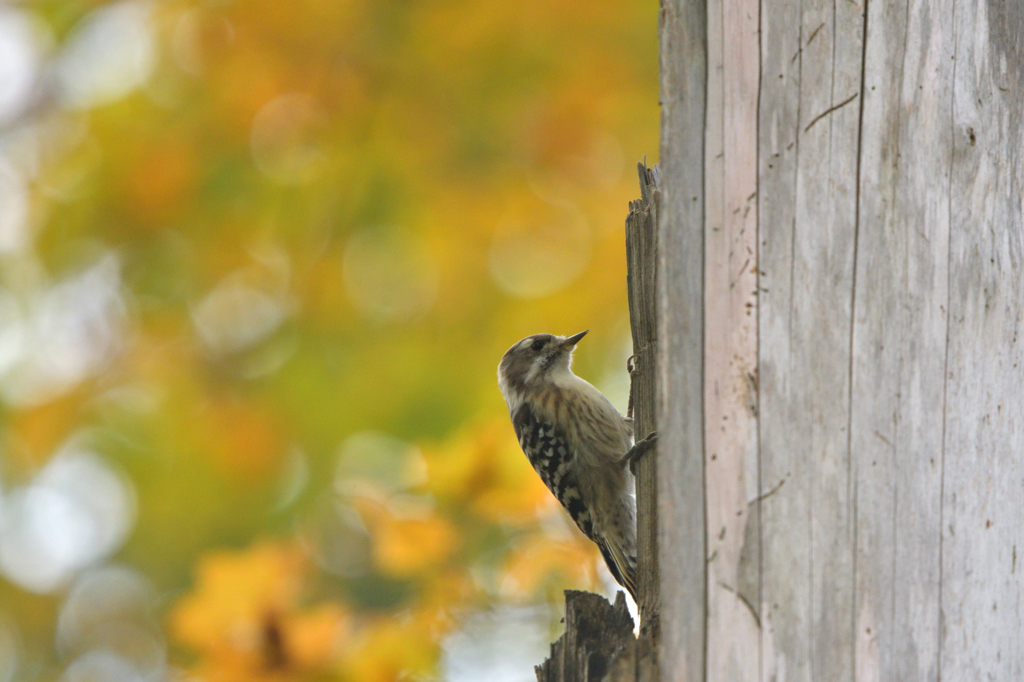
[{"xmin": 657, "ymin": 0, "xmax": 708, "ymax": 682}]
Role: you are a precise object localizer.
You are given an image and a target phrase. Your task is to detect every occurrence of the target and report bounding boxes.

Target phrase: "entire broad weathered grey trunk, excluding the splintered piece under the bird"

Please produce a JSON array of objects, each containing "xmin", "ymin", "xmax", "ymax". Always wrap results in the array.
[{"xmin": 658, "ymin": 0, "xmax": 1024, "ymax": 682}]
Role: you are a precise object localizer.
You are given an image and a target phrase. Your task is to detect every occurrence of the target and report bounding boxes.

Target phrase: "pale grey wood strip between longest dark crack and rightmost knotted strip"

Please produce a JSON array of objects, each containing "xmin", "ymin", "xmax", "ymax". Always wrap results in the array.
[{"xmin": 850, "ymin": 0, "xmax": 954, "ymax": 680}]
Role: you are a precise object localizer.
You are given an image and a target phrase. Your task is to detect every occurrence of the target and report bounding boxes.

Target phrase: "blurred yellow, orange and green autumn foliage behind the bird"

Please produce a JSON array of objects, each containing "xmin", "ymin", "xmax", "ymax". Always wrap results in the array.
[{"xmin": 0, "ymin": 0, "xmax": 658, "ymax": 682}]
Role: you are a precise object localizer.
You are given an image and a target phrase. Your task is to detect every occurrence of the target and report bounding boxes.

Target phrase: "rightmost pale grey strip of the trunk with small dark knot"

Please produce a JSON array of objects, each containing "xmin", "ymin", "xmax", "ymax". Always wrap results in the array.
[{"xmin": 937, "ymin": 0, "xmax": 1024, "ymax": 680}]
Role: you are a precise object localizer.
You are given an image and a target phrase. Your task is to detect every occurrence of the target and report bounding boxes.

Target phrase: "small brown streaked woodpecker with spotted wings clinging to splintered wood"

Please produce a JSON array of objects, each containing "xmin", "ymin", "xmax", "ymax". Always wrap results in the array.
[{"xmin": 498, "ymin": 331, "xmax": 656, "ymax": 601}]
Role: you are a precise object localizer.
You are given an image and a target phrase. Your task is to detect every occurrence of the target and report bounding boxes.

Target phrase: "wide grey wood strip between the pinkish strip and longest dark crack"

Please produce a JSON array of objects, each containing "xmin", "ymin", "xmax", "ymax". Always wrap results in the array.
[{"xmin": 758, "ymin": 0, "xmax": 864, "ymax": 681}]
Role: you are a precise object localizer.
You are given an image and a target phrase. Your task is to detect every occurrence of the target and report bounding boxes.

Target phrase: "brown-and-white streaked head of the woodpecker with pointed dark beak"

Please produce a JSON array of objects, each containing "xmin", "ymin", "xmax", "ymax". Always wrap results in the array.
[{"xmin": 498, "ymin": 332, "xmax": 587, "ymax": 406}]
